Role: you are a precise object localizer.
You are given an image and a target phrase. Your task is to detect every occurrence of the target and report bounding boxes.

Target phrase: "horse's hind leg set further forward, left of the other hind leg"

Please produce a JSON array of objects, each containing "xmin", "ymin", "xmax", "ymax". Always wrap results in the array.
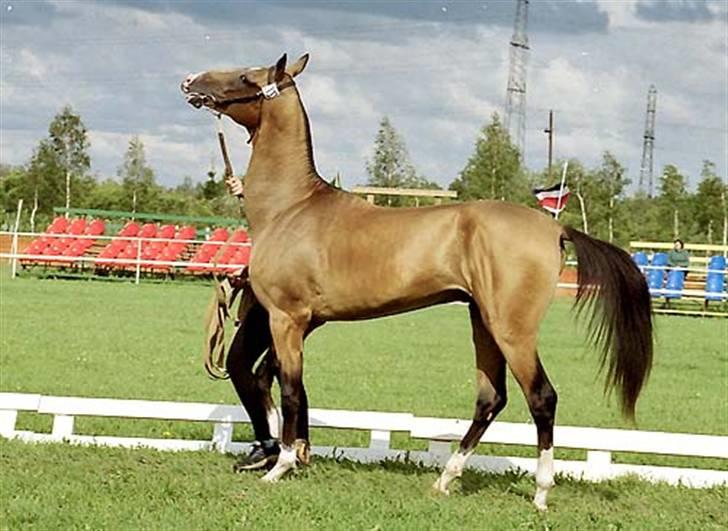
[{"xmin": 433, "ymin": 303, "xmax": 507, "ymax": 494}]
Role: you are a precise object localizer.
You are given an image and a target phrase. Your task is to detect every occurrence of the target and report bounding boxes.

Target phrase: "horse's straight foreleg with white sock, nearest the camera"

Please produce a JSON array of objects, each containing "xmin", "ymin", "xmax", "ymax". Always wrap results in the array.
[{"xmin": 263, "ymin": 312, "xmax": 308, "ymax": 482}]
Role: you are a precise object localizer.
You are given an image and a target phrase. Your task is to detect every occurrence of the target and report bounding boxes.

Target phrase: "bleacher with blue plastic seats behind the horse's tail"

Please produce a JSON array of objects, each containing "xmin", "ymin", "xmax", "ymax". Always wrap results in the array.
[{"xmin": 630, "ymin": 242, "xmax": 728, "ymax": 316}]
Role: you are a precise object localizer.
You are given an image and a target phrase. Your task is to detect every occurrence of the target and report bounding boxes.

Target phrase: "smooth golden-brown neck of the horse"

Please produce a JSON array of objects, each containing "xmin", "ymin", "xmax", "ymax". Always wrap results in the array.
[{"xmin": 245, "ymin": 92, "xmax": 323, "ymax": 233}]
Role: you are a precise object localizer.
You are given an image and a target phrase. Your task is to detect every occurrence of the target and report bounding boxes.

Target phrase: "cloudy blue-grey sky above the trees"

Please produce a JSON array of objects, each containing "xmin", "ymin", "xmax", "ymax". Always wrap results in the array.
[{"xmin": 0, "ymin": 0, "xmax": 728, "ymax": 188}]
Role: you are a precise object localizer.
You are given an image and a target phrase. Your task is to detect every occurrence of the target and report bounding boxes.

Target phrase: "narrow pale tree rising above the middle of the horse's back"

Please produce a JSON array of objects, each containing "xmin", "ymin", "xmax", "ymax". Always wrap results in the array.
[{"xmin": 366, "ymin": 116, "xmax": 424, "ymax": 206}]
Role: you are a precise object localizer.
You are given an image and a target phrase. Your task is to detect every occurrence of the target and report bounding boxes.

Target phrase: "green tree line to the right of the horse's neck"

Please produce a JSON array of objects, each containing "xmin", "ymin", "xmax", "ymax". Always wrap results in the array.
[{"xmin": 367, "ymin": 113, "xmax": 728, "ymax": 245}]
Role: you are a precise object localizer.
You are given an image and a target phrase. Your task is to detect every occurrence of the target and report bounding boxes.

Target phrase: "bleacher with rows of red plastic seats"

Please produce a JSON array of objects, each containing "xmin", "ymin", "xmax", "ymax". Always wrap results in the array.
[{"xmin": 18, "ymin": 211, "xmax": 250, "ymax": 277}]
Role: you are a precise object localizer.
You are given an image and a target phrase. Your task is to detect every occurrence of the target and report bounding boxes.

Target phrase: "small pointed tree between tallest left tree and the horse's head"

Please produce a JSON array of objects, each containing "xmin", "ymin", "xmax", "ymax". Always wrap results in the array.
[{"xmin": 119, "ymin": 136, "xmax": 159, "ymax": 213}]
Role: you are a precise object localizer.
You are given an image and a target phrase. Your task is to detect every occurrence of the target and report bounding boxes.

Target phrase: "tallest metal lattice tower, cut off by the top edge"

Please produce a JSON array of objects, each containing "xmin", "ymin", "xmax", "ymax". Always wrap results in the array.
[{"xmin": 505, "ymin": 0, "xmax": 530, "ymax": 161}]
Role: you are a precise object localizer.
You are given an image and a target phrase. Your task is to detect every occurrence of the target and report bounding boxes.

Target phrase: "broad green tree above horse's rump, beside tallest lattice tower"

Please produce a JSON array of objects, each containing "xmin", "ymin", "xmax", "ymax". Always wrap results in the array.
[{"xmin": 450, "ymin": 113, "xmax": 527, "ymax": 201}]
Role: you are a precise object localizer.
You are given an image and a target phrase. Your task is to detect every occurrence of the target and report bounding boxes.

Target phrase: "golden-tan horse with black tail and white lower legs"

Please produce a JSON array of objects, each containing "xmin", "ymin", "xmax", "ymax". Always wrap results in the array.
[{"xmin": 181, "ymin": 54, "xmax": 653, "ymax": 510}]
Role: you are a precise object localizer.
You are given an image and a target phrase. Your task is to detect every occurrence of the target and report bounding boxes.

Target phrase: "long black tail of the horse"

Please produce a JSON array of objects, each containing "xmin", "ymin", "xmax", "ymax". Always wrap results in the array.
[{"xmin": 563, "ymin": 227, "xmax": 652, "ymax": 419}]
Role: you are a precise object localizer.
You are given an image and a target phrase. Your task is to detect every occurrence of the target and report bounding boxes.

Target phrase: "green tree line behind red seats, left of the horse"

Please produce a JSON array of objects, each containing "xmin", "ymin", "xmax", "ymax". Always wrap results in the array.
[{"xmin": 0, "ymin": 106, "xmax": 245, "ymax": 231}]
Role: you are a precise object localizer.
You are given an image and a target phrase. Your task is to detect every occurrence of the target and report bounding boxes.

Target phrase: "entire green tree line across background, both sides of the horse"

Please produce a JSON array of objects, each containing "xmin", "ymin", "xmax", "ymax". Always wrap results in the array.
[{"xmin": 0, "ymin": 106, "xmax": 728, "ymax": 250}]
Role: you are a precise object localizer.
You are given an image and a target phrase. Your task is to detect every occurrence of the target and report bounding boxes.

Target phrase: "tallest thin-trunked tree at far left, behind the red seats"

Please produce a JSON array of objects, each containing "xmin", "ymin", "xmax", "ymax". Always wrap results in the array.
[{"xmin": 48, "ymin": 105, "xmax": 91, "ymax": 215}]
